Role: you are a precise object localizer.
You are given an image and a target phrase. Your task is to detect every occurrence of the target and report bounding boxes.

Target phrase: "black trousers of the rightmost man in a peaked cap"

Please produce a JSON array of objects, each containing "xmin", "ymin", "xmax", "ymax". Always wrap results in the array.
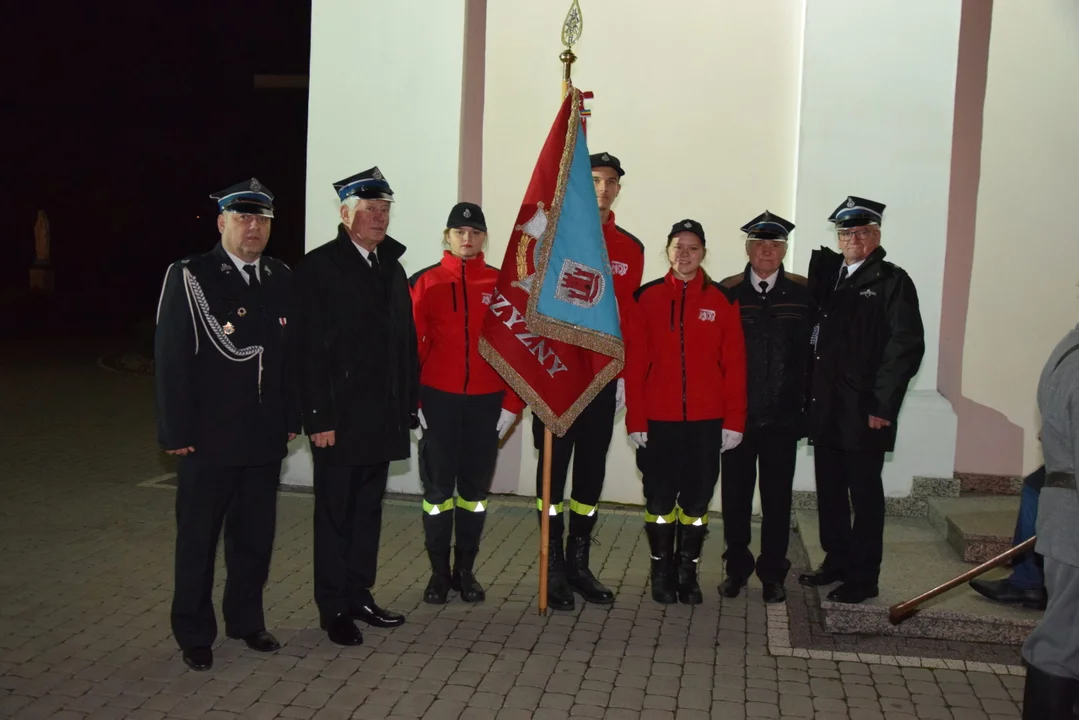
[{"xmin": 814, "ymin": 446, "xmax": 884, "ymax": 585}]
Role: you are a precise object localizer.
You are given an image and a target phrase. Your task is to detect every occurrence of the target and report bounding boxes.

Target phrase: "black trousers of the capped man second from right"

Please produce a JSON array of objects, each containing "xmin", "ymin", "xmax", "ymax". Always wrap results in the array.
[{"xmin": 720, "ymin": 427, "xmax": 798, "ymax": 583}]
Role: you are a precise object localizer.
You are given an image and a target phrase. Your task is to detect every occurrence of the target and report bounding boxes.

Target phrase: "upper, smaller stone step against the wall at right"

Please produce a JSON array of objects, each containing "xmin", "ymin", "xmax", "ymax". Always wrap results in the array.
[{"xmin": 927, "ymin": 494, "xmax": 1019, "ymax": 562}]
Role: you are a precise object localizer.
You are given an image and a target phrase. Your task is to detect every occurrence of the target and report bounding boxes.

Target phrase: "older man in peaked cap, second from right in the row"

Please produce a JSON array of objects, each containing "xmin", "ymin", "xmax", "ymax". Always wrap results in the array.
[{"xmin": 720, "ymin": 212, "xmax": 816, "ymax": 602}]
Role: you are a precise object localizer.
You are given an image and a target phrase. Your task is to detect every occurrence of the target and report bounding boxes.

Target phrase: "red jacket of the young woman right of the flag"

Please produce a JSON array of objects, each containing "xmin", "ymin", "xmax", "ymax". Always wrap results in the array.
[{"xmin": 625, "ymin": 271, "xmax": 746, "ymax": 433}]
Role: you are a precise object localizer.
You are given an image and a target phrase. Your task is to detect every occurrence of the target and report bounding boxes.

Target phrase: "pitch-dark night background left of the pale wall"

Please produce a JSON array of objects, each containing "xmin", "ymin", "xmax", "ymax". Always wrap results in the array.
[{"xmin": 0, "ymin": 0, "xmax": 311, "ymax": 339}]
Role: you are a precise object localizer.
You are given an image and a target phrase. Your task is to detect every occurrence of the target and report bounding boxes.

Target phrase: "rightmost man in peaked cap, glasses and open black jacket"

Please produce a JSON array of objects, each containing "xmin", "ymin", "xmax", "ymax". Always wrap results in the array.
[{"xmin": 798, "ymin": 196, "xmax": 926, "ymax": 602}]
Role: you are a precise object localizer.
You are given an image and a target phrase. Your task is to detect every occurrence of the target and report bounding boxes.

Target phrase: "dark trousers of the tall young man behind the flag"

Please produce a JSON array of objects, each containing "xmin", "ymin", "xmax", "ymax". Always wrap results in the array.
[{"xmin": 532, "ymin": 380, "xmax": 618, "ymax": 536}]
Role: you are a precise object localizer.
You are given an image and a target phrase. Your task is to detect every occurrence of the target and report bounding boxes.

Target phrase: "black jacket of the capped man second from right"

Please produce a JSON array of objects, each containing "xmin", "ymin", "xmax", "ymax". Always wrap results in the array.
[{"xmin": 721, "ymin": 263, "xmax": 817, "ymax": 437}]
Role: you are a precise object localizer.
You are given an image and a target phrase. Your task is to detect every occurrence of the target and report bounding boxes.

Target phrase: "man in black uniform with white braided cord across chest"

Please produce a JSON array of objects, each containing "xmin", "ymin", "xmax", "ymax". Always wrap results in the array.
[{"xmin": 154, "ymin": 178, "xmax": 300, "ymax": 670}]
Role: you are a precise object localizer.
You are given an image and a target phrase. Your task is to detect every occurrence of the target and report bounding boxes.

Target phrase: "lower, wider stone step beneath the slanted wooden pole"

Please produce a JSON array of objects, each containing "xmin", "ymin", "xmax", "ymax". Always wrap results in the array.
[{"xmin": 796, "ymin": 511, "xmax": 1041, "ymax": 644}]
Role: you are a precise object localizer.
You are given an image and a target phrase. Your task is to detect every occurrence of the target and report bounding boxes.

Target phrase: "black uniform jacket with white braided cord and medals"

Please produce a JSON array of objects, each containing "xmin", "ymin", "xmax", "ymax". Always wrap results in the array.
[{"xmin": 154, "ymin": 243, "xmax": 300, "ymax": 465}]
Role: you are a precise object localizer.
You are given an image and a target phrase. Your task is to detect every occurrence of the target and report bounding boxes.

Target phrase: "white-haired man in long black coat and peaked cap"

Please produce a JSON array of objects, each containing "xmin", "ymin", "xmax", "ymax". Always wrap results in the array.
[{"xmin": 291, "ymin": 167, "xmax": 420, "ymax": 646}]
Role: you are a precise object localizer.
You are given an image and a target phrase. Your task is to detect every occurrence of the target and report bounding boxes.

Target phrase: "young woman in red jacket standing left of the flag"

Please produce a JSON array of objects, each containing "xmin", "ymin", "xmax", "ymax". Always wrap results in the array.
[{"xmin": 410, "ymin": 203, "xmax": 524, "ymax": 604}]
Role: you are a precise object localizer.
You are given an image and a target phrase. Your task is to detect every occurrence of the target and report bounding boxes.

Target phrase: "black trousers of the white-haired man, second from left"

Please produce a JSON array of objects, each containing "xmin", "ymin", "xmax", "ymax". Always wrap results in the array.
[{"xmin": 315, "ymin": 457, "xmax": 390, "ymax": 617}]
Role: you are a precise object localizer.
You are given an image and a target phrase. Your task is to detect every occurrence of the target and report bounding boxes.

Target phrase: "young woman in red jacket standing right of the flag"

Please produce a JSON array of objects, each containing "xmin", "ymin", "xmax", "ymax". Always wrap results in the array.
[{"xmin": 625, "ymin": 220, "xmax": 746, "ymax": 604}]
